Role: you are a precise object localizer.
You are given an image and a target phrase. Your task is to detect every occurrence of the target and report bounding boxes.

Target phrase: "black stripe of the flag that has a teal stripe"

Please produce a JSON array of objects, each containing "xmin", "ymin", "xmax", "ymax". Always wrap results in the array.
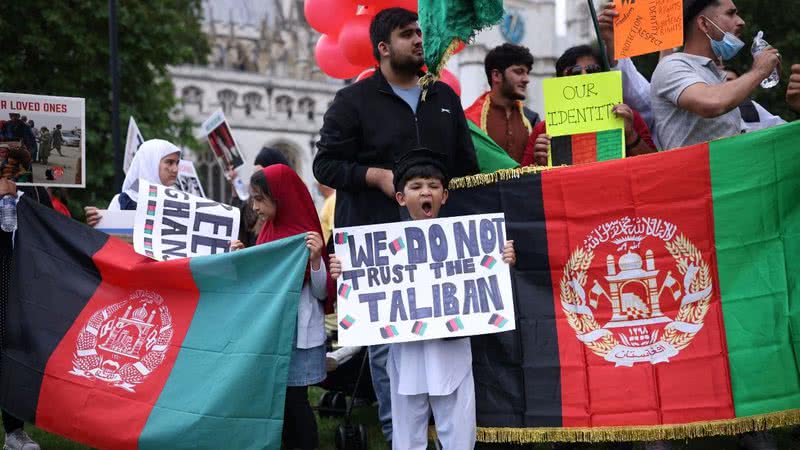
[{"xmin": 0, "ymin": 196, "xmax": 108, "ymax": 423}]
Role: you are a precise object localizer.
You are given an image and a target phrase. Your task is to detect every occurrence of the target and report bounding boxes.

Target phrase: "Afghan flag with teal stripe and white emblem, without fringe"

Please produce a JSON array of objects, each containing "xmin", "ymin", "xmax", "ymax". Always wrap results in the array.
[{"xmin": 0, "ymin": 197, "xmax": 308, "ymax": 449}]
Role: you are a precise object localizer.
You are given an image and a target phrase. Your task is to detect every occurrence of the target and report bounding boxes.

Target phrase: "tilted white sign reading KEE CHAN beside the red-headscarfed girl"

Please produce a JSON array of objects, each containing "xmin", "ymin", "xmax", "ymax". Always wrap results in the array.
[{"xmin": 133, "ymin": 179, "xmax": 240, "ymax": 261}]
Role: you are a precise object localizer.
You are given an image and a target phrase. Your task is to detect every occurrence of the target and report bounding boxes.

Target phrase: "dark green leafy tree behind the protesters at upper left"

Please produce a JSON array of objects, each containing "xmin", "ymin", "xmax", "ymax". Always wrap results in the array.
[{"xmin": 0, "ymin": 0, "xmax": 208, "ymax": 210}]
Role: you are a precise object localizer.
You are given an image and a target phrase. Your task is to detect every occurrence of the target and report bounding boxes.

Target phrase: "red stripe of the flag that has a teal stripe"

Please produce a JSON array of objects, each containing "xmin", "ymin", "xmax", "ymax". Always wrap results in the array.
[{"xmin": 36, "ymin": 239, "xmax": 199, "ymax": 449}]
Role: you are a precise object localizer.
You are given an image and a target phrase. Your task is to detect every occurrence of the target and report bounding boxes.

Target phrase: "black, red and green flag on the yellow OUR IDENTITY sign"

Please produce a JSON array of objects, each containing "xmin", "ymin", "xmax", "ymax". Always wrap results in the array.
[{"xmin": 550, "ymin": 129, "xmax": 624, "ymax": 166}]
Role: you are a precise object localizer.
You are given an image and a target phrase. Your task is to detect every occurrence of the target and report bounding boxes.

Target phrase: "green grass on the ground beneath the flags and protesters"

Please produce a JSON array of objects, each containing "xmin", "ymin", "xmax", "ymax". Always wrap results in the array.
[{"xmin": 10, "ymin": 388, "xmax": 800, "ymax": 450}]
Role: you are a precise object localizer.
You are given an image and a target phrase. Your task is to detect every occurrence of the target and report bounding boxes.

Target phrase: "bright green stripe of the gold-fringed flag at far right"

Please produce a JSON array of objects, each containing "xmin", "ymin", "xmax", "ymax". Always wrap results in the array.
[{"xmin": 708, "ymin": 123, "xmax": 800, "ymax": 417}]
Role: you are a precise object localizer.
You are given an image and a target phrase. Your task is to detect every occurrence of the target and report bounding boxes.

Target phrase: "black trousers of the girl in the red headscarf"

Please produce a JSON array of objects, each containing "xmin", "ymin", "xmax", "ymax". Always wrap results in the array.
[{"xmin": 283, "ymin": 386, "xmax": 319, "ymax": 450}]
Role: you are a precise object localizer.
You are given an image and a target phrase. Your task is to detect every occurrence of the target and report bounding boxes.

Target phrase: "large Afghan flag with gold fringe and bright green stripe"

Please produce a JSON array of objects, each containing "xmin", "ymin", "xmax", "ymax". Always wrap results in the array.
[{"xmin": 446, "ymin": 123, "xmax": 800, "ymax": 442}]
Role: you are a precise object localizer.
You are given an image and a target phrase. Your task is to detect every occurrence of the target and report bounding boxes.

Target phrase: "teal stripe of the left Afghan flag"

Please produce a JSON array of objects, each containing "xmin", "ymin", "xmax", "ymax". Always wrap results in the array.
[{"xmin": 139, "ymin": 235, "xmax": 308, "ymax": 449}]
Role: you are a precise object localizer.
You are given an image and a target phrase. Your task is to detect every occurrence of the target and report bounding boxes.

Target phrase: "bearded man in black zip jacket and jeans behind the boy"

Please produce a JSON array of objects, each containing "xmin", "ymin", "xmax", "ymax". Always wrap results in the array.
[{"xmin": 314, "ymin": 8, "xmax": 478, "ymax": 441}]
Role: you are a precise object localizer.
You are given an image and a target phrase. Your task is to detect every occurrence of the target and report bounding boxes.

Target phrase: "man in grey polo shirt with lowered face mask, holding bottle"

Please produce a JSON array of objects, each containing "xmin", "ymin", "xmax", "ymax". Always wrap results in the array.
[{"xmin": 650, "ymin": 0, "xmax": 780, "ymax": 150}]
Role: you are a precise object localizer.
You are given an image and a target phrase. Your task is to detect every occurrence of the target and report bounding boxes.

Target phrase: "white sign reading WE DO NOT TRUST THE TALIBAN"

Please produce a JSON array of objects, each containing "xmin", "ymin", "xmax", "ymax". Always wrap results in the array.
[{"xmin": 334, "ymin": 214, "xmax": 515, "ymax": 345}]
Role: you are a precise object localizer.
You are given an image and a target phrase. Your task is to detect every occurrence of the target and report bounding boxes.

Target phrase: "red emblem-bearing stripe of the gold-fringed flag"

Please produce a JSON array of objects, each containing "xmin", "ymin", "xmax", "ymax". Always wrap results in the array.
[{"xmin": 542, "ymin": 145, "xmax": 734, "ymax": 427}]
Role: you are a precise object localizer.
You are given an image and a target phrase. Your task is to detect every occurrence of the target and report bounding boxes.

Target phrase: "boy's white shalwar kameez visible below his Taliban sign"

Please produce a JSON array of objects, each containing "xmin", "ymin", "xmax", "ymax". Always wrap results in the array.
[{"xmin": 387, "ymin": 338, "xmax": 477, "ymax": 450}]
